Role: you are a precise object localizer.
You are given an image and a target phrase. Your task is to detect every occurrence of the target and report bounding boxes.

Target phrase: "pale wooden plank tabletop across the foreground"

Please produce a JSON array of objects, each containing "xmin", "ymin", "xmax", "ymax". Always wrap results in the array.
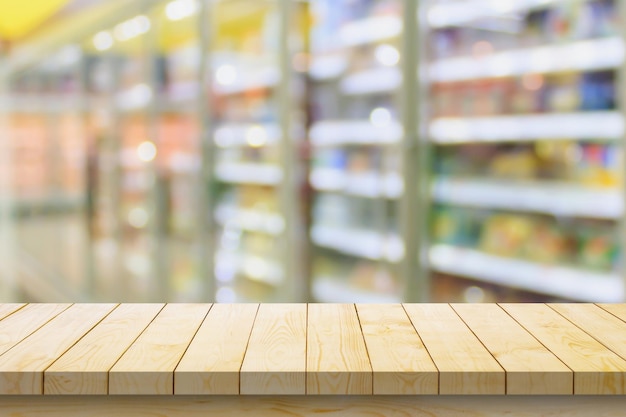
[{"xmin": 0, "ymin": 304, "xmax": 626, "ymax": 395}]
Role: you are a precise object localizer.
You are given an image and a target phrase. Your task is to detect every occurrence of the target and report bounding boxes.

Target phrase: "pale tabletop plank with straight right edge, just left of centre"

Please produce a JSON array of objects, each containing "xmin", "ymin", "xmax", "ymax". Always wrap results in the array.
[{"xmin": 240, "ymin": 304, "xmax": 307, "ymax": 395}]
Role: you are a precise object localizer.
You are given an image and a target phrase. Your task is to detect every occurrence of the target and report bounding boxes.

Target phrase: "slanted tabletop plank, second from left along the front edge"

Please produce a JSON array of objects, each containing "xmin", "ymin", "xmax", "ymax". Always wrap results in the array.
[{"xmin": 44, "ymin": 304, "xmax": 164, "ymax": 395}]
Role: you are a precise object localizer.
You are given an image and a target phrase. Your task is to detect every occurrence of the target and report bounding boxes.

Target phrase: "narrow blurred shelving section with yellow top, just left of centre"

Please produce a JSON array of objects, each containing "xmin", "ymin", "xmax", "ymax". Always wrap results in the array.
[{"xmin": 207, "ymin": 0, "xmax": 306, "ymax": 302}]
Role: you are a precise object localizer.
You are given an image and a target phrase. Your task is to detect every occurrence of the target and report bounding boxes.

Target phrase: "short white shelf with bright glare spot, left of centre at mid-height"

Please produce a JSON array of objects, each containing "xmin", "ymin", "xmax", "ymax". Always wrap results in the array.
[{"xmin": 215, "ymin": 123, "xmax": 282, "ymax": 148}]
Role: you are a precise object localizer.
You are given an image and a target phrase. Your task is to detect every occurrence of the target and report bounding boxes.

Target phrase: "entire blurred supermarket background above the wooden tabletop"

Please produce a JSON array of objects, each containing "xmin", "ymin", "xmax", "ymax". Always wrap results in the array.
[{"xmin": 0, "ymin": 0, "xmax": 626, "ymax": 302}]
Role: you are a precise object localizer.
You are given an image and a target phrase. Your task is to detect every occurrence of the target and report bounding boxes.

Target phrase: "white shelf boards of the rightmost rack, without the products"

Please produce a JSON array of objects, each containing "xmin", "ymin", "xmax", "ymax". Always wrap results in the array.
[{"xmin": 423, "ymin": 0, "xmax": 626, "ymax": 302}]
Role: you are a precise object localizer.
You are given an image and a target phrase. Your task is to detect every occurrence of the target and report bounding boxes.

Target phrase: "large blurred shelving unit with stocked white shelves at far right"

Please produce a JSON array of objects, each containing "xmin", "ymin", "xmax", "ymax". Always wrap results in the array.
[{"xmin": 425, "ymin": 0, "xmax": 625, "ymax": 302}]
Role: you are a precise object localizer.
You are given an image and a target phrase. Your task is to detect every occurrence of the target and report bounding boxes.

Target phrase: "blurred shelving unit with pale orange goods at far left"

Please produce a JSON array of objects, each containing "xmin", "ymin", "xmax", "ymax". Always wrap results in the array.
[{"xmin": 2, "ymin": 45, "xmax": 90, "ymax": 300}]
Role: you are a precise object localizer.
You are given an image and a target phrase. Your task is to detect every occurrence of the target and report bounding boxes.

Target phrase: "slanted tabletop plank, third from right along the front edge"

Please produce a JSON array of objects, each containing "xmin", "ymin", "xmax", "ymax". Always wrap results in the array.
[{"xmin": 404, "ymin": 304, "xmax": 505, "ymax": 395}]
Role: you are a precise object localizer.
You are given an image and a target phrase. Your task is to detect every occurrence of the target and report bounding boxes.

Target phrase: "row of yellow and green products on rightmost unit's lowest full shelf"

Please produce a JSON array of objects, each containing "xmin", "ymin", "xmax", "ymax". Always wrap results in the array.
[{"xmin": 432, "ymin": 207, "xmax": 619, "ymax": 272}]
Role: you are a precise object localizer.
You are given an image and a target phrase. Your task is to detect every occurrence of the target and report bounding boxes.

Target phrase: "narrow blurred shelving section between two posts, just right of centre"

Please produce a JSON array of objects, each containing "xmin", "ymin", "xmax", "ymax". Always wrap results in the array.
[{"xmin": 308, "ymin": 1, "xmax": 404, "ymax": 302}]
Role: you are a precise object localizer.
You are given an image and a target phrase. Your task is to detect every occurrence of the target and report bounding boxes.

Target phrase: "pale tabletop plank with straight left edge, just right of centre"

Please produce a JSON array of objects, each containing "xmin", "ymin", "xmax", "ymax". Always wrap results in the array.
[{"xmin": 307, "ymin": 304, "xmax": 372, "ymax": 395}]
